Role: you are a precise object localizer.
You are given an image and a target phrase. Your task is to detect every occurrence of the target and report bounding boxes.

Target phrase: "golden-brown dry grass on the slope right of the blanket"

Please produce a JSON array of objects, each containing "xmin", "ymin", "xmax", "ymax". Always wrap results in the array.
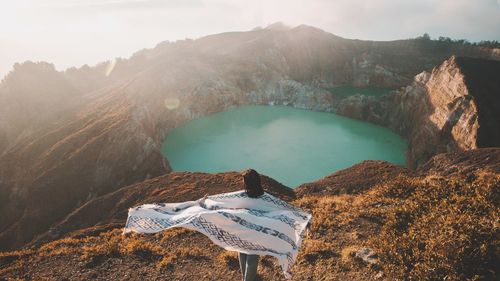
[{"xmin": 296, "ymin": 173, "xmax": 500, "ymax": 280}]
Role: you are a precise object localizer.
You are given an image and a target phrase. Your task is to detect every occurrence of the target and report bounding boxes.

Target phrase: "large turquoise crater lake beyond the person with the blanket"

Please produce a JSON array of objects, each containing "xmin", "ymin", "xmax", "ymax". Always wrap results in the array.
[{"xmin": 162, "ymin": 106, "xmax": 407, "ymax": 187}]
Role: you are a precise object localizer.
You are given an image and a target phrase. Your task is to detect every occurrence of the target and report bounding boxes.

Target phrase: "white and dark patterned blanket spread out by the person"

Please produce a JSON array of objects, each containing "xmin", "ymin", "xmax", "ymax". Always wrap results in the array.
[{"xmin": 124, "ymin": 191, "xmax": 311, "ymax": 278}]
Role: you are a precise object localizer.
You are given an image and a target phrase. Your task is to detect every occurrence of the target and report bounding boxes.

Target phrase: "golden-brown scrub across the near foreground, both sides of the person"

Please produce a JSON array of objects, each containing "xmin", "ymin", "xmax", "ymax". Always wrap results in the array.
[{"xmin": 0, "ymin": 173, "xmax": 500, "ymax": 280}]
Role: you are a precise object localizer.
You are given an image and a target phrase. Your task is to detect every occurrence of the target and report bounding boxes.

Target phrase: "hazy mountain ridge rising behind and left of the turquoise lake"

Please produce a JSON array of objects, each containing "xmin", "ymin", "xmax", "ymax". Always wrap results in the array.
[{"xmin": 0, "ymin": 24, "xmax": 499, "ymax": 250}]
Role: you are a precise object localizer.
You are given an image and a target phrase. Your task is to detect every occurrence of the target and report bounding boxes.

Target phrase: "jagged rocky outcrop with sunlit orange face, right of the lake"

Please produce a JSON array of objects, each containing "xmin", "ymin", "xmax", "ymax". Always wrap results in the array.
[{"xmin": 336, "ymin": 57, "xmax": 500, "ymax": 167}]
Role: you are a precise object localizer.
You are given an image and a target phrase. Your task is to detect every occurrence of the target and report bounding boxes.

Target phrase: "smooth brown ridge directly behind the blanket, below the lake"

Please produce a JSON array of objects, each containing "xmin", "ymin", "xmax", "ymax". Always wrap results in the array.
[{"xmin": 27, "ymin": 172, "xmax": 295, "ymax": 244}]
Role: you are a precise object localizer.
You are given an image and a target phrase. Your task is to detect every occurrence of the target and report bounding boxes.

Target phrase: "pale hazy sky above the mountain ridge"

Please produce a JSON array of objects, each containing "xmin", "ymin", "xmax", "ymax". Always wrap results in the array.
[{"xmin": 0, "ymin": 0, "xmax": 500, "ymax": 78}]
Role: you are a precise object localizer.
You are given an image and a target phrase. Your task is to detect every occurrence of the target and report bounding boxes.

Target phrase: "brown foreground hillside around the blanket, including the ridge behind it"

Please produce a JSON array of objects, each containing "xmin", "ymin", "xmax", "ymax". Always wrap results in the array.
[{"xmin": 0, "ymin": 148, "xmax": 500, "ymax": 280}]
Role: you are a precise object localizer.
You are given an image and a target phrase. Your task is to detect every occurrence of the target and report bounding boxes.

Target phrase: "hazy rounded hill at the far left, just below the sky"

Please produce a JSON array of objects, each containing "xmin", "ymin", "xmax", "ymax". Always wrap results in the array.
[{"xmin": 0, "ymin": 62, "xmax": 81, "ymax": 152}]
